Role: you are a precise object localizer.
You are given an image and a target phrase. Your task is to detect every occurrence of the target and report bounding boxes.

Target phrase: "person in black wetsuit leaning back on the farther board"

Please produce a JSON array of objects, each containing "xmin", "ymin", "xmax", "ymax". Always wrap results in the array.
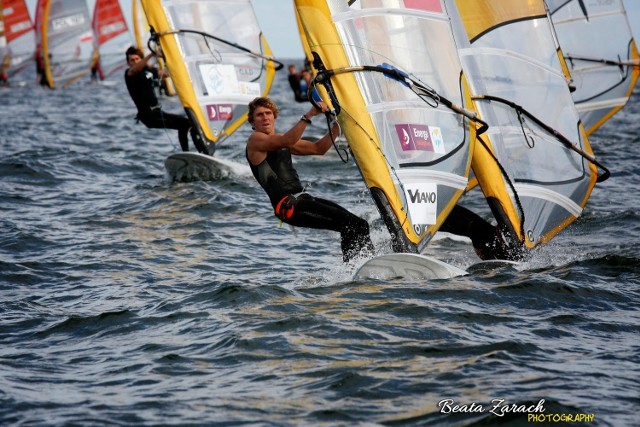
[{"xmin": 124, "ymin": 46, "xmax": 209, "ymax": 154}]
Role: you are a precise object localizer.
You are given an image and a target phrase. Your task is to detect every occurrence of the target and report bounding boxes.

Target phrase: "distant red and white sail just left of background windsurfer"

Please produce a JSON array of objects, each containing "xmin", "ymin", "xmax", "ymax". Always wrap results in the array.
[{"xmin": 91, "ymin": 0, "xmax": 132, "ymax": 80}]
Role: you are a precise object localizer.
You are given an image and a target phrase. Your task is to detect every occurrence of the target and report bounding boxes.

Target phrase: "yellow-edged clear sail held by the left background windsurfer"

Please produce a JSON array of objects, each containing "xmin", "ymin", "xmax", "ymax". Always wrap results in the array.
[{"xmin": 142, "ymin": 0, "xmax": 282, "ymax": 181}]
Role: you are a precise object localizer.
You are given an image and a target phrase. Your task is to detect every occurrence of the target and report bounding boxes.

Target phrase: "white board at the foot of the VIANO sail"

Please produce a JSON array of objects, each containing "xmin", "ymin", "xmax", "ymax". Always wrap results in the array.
[{"xmin": 354, "ymin": 253, "xmax": 467, "ymax": 280}]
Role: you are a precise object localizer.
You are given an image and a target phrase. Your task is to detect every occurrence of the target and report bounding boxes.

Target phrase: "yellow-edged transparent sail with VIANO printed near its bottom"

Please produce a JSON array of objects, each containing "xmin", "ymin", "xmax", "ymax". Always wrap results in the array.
[{"xmin": 295, "ymin": 0, "xmax": 490, "ymax": 280}]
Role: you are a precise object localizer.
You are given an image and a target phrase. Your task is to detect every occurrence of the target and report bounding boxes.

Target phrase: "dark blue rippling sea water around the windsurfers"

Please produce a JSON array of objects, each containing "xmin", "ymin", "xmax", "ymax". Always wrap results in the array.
[{"xmin": 0, "ymin": 68, "xmax": 640, "ymax": 426}]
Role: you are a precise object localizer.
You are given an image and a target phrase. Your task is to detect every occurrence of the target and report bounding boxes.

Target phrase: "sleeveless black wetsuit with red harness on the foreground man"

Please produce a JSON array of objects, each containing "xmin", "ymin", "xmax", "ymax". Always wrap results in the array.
[{"xmin": 247, "ymin": 148, "xmax": 373, "ymax": 262}]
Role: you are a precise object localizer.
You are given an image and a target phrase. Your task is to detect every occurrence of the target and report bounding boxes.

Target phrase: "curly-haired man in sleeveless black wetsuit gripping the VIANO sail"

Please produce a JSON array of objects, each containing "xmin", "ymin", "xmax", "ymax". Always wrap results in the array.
[{"xmin": 246, "ymin": 97, "xmax": 373, "ymax": 262}]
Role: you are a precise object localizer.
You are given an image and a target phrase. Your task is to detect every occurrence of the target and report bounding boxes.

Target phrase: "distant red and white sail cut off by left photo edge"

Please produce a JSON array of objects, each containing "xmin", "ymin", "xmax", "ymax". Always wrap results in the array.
[{"xmin": 0, "ymin": 0, "xmax": 36, "ymax": 79}]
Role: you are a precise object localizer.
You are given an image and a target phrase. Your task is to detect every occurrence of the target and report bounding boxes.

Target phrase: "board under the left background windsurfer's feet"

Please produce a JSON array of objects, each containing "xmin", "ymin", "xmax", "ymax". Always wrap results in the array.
[{"xmin": 164, "ymin": 152, "xmax": 251, "ymax": 181}]
